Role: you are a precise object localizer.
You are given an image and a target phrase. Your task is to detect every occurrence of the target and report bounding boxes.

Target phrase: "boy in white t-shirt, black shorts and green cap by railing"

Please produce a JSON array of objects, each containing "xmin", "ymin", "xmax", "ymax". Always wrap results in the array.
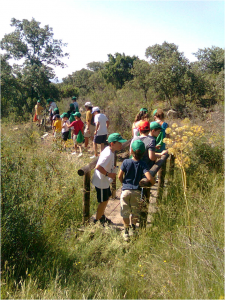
[{"xmin": 92, "ymin": 133, "xmax": 126, "ymax": 225}]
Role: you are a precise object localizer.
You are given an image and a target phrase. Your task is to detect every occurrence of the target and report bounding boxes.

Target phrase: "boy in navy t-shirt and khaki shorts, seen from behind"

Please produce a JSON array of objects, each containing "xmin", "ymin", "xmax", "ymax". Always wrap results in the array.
[{"xmin": 118, "ymin": 140, "xmax": 155, "ymax": 241}]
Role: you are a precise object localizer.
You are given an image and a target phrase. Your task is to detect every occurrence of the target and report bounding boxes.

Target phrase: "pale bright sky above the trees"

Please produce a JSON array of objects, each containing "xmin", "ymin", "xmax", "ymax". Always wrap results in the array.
[{"xmin": 0, "ymin": 0, "xmax": 225, "ymax": 81}]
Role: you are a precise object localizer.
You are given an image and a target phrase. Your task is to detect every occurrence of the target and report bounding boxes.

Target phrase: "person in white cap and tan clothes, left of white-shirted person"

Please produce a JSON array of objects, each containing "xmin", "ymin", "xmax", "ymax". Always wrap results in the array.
[{"xmin": 84, "ymin": 102, "xmax": 95, "ymax": 149}]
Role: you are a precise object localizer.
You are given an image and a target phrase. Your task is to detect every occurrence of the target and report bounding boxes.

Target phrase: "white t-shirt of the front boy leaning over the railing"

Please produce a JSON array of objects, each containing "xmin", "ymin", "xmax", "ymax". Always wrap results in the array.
[{"xmin": 92, "ymin": 146, "xmax": 114, "ymax": 189}]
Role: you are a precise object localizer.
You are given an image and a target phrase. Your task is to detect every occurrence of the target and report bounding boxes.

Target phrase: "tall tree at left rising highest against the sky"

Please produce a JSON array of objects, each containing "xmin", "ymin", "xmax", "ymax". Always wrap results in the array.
[{"xmin": 1, "ymin": 18, "xmax": 68, "ymax": 103}]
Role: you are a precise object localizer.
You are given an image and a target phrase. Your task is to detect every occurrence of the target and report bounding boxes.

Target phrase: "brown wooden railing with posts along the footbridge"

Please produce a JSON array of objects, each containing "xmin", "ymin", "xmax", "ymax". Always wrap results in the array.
[{"xmin": 78, "ymin": 139, "xmax": 173, "ymax": 226}]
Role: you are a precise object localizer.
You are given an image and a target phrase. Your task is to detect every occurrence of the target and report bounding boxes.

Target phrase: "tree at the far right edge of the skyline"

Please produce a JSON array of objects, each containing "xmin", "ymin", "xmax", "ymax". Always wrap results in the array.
[{"xmin": 193, "ymin": 46, "xmax": 224, "ymax": 74}]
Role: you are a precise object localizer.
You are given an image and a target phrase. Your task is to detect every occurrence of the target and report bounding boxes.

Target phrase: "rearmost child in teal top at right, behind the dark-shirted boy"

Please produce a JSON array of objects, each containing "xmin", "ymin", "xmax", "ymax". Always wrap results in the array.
[{"xmin": 153, "ymin": 108, "xmax": 169, "ymax": 153}]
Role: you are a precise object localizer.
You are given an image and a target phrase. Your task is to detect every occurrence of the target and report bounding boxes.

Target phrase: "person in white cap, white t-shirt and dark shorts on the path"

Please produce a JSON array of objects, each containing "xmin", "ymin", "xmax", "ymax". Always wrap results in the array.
[{"xmin": 90, "ymin": 106, "xmax": 109, "ymax": 158}]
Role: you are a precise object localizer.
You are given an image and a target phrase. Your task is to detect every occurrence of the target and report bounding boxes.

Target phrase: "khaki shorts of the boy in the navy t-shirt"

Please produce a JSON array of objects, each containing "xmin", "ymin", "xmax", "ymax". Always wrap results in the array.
[{"xmin": 120, "ymin": 190, "xmax": 141, "ymax": 218}]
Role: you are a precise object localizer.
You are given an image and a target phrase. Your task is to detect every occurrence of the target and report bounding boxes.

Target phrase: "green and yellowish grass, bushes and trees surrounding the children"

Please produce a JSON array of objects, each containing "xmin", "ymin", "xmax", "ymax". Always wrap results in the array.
[{"xmin": 1, "ymin": 19, "xmax": 224, "ymax": 299}]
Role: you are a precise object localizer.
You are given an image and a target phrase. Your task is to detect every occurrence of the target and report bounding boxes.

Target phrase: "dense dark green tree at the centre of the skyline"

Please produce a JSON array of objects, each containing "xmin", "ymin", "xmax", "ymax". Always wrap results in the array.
[{"xmin": 101, "ymin": 53, "xmax": 138, "ymax": 89}]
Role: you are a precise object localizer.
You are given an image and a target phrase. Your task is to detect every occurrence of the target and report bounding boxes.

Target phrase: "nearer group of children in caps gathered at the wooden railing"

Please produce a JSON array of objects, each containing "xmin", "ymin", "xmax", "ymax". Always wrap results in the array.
[{"xmin": 92, "ymin": 108, "xmax": 168, "ymax": 241}]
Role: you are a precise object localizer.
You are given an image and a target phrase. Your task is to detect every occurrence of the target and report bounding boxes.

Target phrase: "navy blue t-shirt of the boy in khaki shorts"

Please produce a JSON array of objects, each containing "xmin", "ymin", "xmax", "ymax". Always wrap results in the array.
[{"xmin": 120, "ymin": 158, "xmax": 149, "ymax": 190}]
